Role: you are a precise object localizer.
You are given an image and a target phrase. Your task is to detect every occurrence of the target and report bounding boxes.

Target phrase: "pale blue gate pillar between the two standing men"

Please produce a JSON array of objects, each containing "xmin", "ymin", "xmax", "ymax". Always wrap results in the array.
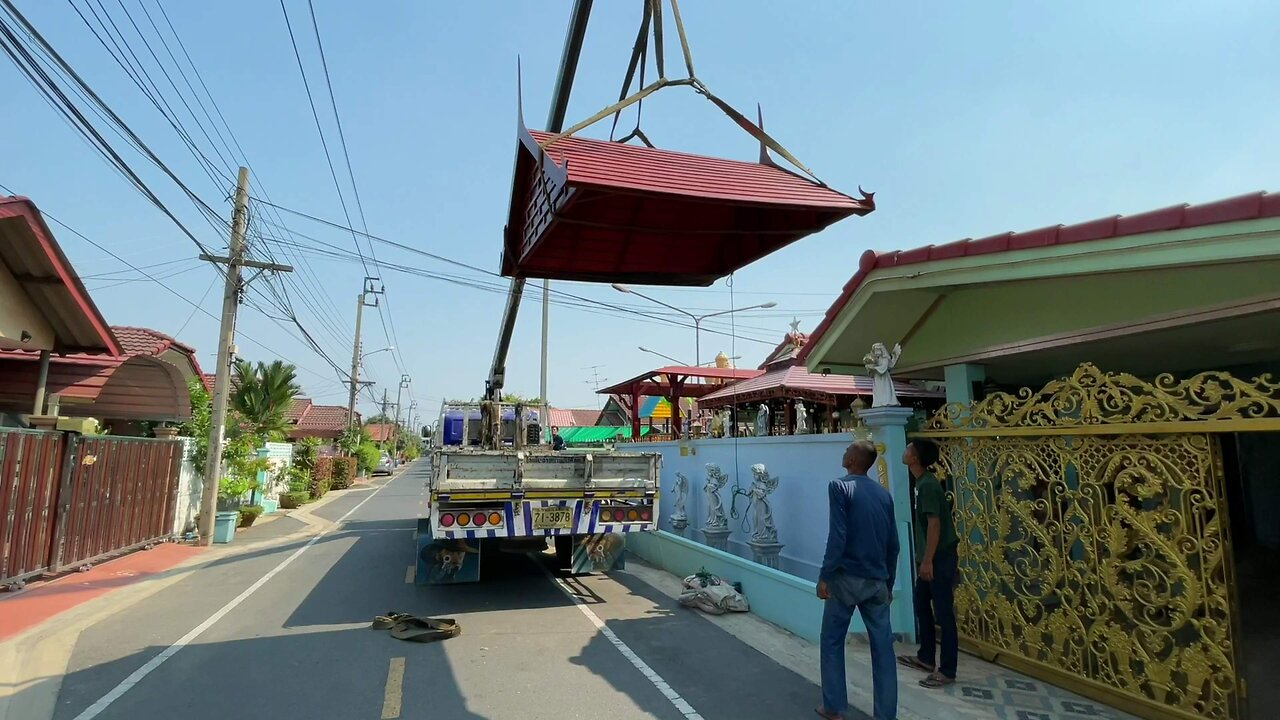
[{"xmin": 859, "ymin": 406, "xmax": 915, "ymax": 643}]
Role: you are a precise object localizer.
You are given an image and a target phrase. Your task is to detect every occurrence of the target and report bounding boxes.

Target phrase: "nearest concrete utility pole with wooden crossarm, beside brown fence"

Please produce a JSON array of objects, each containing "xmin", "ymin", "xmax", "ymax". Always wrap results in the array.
[{"xmin": 200, "ymin": 168, "xmax": 293, "ymax": 544}]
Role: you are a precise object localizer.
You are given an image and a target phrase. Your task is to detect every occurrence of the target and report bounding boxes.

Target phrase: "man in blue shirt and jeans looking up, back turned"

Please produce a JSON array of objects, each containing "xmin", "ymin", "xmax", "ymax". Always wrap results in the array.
[{"xmin": 817, "ymin": 441, "xmax": 899, "ymax": 720}]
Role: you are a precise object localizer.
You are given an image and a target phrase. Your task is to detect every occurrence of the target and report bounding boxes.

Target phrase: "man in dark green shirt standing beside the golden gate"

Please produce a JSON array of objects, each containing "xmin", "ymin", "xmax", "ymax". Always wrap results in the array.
[{"xmin": 897, "ymin": 439, "xmax": 960, "ymax": 688}]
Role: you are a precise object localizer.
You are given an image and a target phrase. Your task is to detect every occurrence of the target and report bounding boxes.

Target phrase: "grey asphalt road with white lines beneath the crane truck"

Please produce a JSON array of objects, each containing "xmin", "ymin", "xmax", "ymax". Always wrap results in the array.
[{"xmin": 40, "ymin": 464, "xmax": 859, "ymax": 720}]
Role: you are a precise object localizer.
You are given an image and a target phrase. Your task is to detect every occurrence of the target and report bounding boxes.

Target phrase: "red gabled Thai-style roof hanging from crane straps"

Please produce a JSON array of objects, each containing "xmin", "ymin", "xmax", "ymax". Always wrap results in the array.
[{"xmin": 502, "ymin": 128, "xmax": 876, "ymax": 286}]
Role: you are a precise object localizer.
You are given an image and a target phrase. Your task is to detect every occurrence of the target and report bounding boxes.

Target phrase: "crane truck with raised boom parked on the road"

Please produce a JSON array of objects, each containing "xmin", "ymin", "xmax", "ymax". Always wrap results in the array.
[{"xmin": 416, "ymin": 0, "xmax": 662, "ymax": 584}]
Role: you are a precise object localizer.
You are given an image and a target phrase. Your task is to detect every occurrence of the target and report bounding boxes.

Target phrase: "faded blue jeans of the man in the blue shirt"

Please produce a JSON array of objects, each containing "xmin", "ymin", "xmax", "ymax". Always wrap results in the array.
[{"xmin": 820, "ymin": 573, "xmax": 897, "ymax": 720}]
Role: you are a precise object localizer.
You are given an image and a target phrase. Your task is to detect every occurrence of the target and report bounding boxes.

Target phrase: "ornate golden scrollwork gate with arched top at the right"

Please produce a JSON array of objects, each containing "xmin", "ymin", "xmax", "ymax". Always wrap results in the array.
[{"xmin": 916, "ymin": 364, "xmax": 1280, "ymax": 720}]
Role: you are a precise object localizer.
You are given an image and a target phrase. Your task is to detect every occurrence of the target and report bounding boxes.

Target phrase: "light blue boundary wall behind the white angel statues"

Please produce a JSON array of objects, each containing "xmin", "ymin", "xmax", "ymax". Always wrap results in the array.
[{"xmin": 645, "ymin": 433, "xmax": 885, "ymax": 582}]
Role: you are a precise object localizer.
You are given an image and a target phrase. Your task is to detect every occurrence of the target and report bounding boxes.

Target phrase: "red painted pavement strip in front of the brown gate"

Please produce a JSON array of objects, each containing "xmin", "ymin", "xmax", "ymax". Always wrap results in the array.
[{"xmin": 0, "ymin": 543, "xmax": 205, "ymax": 642}]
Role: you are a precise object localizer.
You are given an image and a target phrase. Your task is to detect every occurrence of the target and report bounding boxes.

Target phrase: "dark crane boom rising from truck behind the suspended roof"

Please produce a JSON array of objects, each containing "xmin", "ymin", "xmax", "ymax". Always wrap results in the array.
[{"xmin": 481, "ymin": 0, "xmax": 591, "ymax": 448}]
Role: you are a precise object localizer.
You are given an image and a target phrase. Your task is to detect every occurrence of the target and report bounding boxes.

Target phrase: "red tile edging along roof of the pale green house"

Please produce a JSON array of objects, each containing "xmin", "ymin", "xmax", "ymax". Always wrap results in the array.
[{"xmin": 800, "ymin": 191, "xmax": 1280, "ymax": 360}]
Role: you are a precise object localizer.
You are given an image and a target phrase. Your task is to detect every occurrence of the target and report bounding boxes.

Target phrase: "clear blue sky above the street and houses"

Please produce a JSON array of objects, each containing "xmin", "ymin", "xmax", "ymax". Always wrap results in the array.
[{"xmin": 0, "ymin": 0, "xmax": 1280, "ymax": 416}]
